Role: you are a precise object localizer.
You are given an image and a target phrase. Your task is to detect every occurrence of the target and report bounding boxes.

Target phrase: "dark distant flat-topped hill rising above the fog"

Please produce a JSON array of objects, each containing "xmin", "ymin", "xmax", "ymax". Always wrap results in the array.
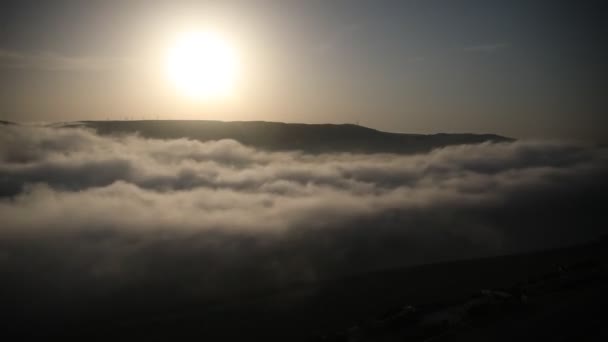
[{"xmin": 59, "ymin": 120, "xmax": 513, "ymax": 153}]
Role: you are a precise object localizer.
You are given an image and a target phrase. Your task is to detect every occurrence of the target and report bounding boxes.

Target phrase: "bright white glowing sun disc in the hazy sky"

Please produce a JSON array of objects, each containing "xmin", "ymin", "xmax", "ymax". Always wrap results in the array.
[{"xmin": 167, "ymin": 31, "xmax": 239, "ymax": 100}]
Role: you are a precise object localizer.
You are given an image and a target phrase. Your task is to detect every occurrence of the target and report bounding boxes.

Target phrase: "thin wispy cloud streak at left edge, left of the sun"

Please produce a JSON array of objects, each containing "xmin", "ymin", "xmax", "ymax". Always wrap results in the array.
[{"xmin": 0, "ymin": 49, "xmax": 128, "ymax": 71}]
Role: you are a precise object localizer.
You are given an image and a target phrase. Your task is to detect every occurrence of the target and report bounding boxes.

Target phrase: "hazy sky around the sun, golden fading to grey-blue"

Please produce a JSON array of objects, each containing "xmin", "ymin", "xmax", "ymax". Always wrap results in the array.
[{"xmin": 0, "ymin": 0, "xmax": 608, "ymax": 143}]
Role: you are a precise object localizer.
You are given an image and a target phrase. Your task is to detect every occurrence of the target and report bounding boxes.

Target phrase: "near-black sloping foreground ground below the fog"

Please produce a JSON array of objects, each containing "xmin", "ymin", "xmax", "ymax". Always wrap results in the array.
[{"xmin": 3, "ymin": 235, "xmax": 608, "ymax": 341}]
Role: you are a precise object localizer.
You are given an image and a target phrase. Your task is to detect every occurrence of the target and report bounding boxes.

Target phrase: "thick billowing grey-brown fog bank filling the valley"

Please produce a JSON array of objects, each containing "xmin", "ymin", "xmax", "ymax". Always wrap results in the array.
[{"xmin": 0, "ymin": 126, "xmax": 608, "ymax": 316}]
